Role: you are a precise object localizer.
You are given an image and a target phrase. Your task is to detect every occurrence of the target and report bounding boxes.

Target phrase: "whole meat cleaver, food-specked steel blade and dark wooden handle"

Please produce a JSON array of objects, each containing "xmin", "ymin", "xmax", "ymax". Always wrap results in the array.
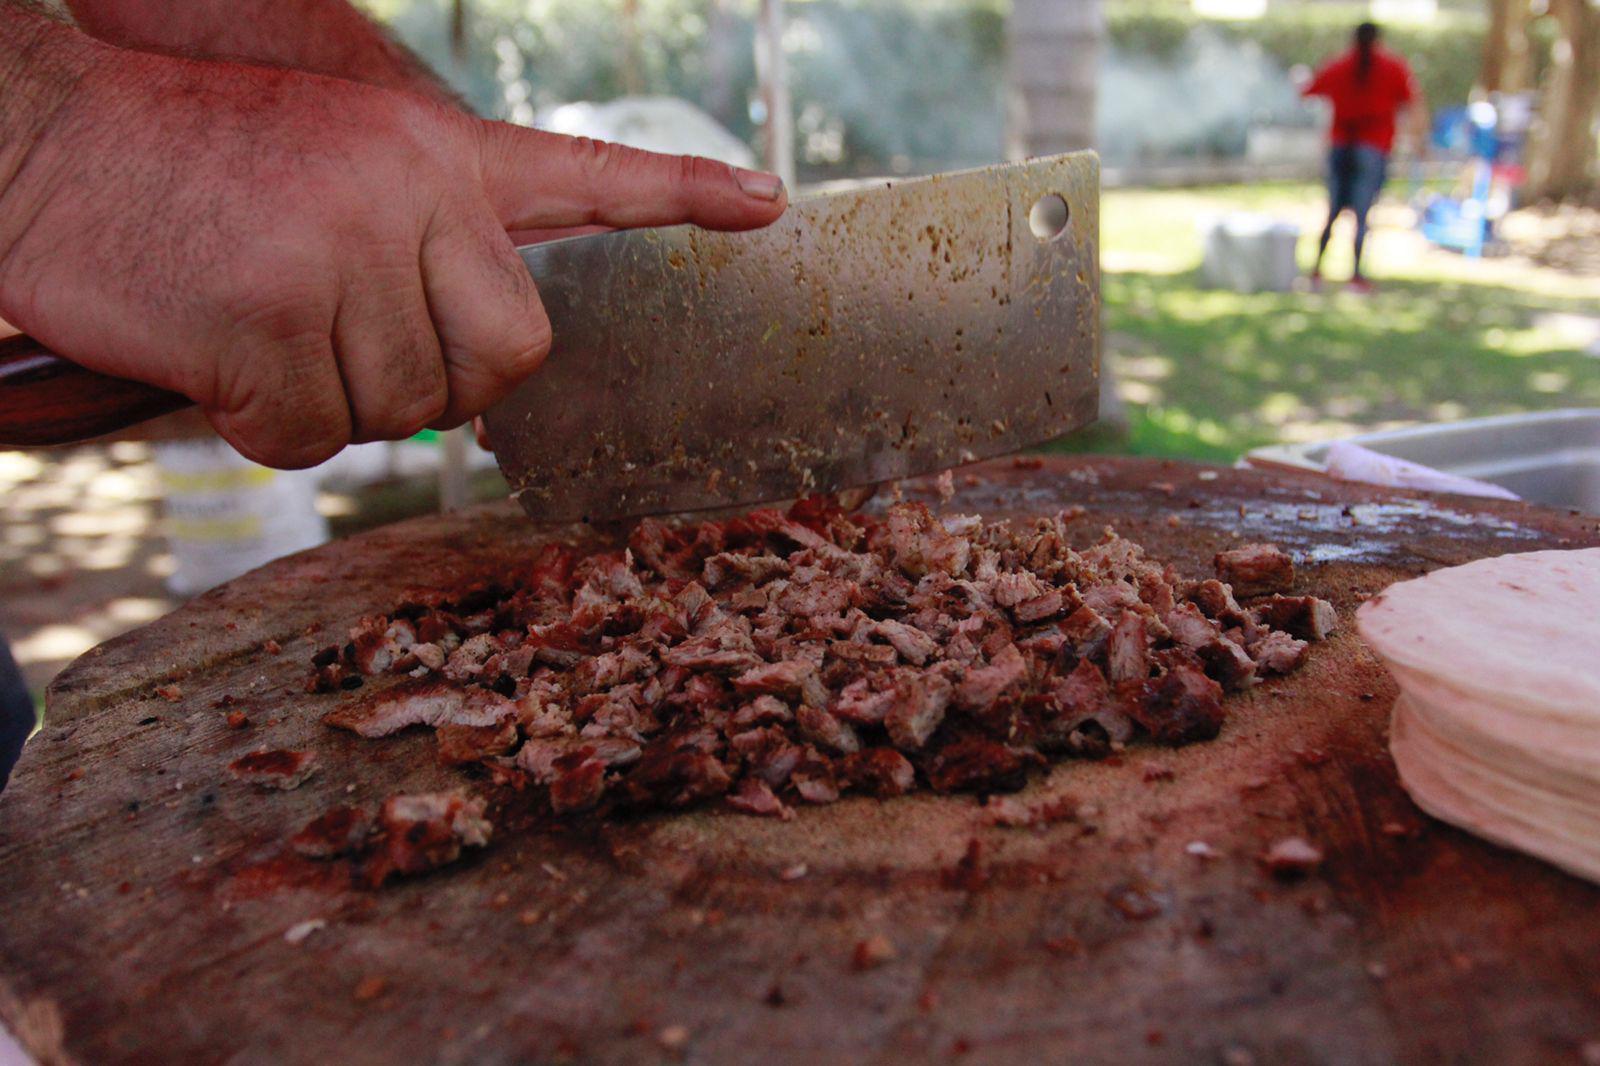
[{"xmin": 0, "ymin": 152, "xmax": 1099, "ymax": 522}]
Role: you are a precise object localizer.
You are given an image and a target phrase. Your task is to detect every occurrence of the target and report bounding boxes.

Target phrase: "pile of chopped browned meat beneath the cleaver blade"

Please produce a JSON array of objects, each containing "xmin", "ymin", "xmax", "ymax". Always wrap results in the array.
[{"xmin": 307, "ymin": 498, "xmax": 1336, "ymax": 819}]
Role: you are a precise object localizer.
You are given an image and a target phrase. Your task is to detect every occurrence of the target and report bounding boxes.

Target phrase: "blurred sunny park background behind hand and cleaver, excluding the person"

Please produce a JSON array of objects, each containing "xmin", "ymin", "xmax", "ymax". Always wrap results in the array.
[{"xmin": 0, "ymin": 0, "xmax": 1600, "ymax": 704}]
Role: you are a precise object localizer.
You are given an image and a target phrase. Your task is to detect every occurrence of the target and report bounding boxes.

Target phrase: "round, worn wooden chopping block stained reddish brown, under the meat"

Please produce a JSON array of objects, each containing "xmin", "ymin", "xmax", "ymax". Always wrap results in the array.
[{"xmin": 0, "ymin": 458, "xmax": 1600, "ymax": 1064}]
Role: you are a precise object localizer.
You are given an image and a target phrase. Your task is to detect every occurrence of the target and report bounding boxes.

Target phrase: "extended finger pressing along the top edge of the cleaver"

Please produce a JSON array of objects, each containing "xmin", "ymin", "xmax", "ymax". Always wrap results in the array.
[{"xmin": 467, "ymin": 122, "xmax": 787, "ymax": 229}]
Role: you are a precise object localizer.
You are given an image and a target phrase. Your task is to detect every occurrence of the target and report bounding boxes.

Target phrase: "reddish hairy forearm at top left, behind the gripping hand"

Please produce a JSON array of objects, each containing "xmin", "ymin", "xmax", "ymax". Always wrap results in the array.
[{"xmin": 67, "ymin": 0, "xmax": 461, "ymax": 106}]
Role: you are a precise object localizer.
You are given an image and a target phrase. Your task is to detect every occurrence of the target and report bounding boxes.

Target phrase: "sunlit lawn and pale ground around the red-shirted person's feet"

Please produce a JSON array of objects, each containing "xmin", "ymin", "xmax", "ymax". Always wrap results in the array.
[{"xmin": 1058, "ymin": 184, "xmax": 1600, "ymax": 461}]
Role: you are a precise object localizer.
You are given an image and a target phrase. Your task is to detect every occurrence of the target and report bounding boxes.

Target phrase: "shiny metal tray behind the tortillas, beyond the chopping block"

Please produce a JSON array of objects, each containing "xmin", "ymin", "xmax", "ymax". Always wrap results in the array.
[{"xmin": 1245, "ymin": 407, "xmax": 1600, "ymax": 514}]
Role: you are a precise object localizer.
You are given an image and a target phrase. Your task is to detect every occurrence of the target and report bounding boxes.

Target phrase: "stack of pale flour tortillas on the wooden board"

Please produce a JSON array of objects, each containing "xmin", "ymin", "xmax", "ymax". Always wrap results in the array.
[{"xmin": 1355, "ymin": 549, "xmax": 1600, "ymax": 880}]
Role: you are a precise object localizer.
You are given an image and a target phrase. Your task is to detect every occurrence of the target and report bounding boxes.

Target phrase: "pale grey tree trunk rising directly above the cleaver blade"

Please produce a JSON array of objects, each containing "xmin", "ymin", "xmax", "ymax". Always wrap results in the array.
[{"xmin": 1006, "ymin": 0, "xmax": 1104, "ymax": 158}]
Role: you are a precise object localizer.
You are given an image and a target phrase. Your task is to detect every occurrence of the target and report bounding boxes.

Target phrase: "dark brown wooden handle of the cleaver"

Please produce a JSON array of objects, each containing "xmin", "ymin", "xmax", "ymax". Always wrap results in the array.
[{"xmin": 0, "ymin": 336, "xmax": 190, "ymax": 448}]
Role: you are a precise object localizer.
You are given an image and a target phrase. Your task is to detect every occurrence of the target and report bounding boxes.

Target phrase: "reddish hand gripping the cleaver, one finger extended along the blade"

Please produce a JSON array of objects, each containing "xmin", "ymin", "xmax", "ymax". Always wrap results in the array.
[{"xmin": 0, "ymin": 46, "xmax": 786, "ymax": 467}]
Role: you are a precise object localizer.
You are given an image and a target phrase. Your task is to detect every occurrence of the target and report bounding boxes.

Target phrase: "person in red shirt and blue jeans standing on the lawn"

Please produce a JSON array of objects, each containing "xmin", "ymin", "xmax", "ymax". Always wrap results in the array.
[{"xmin": 1301, "ymin": 22, "xmax": 1421, "ymax": 293}]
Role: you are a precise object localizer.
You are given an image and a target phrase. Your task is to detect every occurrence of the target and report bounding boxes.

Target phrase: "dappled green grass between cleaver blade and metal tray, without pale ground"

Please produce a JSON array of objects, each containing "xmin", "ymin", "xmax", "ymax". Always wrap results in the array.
[{"xmin": 1104, "ymin": 274, "xmax": 1600, "ymax": 453}]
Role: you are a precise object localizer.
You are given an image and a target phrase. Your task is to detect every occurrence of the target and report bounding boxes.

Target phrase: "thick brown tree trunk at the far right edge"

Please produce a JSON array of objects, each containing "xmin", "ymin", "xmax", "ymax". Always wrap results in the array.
[{"xmin": 1528, "ymin": 0, "xmax": 1600, "ymax": 200}]
